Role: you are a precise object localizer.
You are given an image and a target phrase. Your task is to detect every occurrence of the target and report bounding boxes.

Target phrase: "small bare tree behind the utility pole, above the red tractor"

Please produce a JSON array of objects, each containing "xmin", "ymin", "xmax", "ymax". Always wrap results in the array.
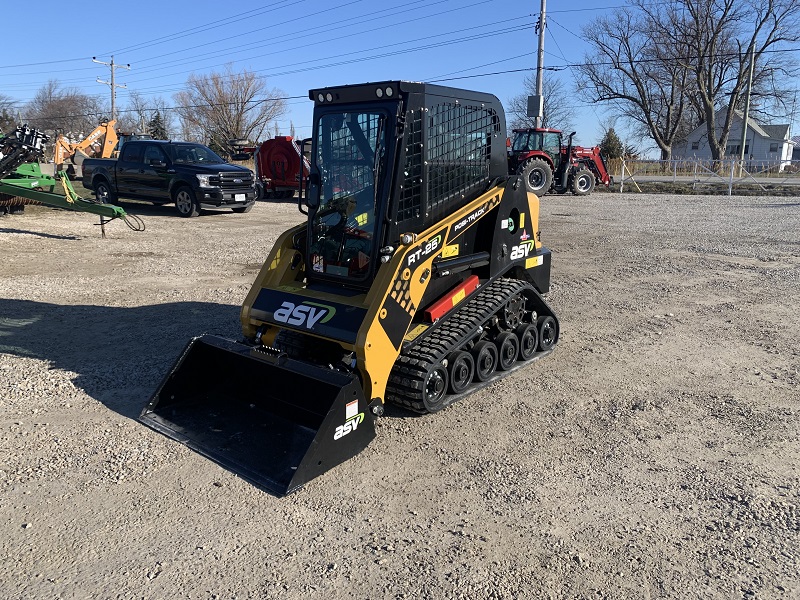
[{"xmin": 506, "ymin": 74, "xmax": 576, "ymax": 131}]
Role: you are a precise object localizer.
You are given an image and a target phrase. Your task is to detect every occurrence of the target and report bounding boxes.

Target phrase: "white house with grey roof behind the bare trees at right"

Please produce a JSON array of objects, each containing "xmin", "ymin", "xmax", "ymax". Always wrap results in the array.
[{"xmin": 672, "ymin": 109, "xmax": 795, "ymax": 169}]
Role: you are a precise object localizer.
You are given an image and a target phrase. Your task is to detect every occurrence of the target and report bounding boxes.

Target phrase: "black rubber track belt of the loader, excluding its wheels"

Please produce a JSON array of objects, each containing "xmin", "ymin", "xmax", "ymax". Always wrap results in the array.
[{"xmin": 386, "ymin": 278, "xmax": 551, "ymax": 414}]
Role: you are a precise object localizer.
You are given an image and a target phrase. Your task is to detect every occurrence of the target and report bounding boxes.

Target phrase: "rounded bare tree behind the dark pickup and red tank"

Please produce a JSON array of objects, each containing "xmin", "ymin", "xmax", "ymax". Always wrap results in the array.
[{"xmin": 175, "ymin": 65, "xmax": 286, "ymax": 147}]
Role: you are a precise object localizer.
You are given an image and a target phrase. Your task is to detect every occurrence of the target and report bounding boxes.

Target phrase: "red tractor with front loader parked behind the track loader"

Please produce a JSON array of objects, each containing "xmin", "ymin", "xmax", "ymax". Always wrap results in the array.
[{"xmin": 508, "ymin": 129, "xmax": 612, "ymax": 196}]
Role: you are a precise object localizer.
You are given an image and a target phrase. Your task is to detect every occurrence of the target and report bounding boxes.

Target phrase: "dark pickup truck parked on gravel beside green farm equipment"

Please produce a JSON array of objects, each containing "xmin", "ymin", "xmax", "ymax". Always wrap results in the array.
[{"xmin": 83, "ymin": 140, "xmax": 256, "ymax": 217}]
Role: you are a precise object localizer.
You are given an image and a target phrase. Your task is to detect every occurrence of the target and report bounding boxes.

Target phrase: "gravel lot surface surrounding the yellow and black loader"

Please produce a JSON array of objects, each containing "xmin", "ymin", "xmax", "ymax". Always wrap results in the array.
[{"xmin": 0, "ymin": 193, "xmax": 800, "ymax": 600}]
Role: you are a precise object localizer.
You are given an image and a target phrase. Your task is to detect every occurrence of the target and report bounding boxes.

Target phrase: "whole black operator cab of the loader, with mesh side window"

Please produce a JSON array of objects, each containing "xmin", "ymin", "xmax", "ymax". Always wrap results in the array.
[{"xmin": 304, "ymin": 81, "xmax": 508, "ymax": 290}]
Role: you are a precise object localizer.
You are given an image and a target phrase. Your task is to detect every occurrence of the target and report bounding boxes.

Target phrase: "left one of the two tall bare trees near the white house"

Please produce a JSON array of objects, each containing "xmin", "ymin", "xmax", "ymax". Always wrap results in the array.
[{"xmin": 579, "ymin": 7, "xmax": 689, "ymax": 160}]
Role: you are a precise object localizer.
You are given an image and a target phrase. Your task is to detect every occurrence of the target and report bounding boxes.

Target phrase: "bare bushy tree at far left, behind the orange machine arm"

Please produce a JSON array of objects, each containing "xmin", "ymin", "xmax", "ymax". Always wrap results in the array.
[{"xmin": 23, "ymin": 79, "xmax": 109, "ymax": 138}]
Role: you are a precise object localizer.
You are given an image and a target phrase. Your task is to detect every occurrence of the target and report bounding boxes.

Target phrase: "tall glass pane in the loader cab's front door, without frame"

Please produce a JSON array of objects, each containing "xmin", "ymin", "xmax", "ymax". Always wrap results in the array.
[{"xmin": 309, "ymin": 111, "xmax": 386, "ymax": 280}]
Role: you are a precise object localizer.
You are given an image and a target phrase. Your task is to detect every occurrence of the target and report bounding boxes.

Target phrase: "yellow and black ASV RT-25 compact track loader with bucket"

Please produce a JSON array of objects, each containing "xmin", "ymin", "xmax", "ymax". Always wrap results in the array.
[{"xmin": 141, "ymin": 81, "xmax": 559, "ymax": 495}]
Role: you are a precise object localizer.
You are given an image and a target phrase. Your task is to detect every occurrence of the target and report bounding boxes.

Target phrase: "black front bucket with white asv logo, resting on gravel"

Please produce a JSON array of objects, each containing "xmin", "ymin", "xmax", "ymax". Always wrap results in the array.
[{"xmin": 139, "ymin": 336, "xmax": 375, "ymax": 496}]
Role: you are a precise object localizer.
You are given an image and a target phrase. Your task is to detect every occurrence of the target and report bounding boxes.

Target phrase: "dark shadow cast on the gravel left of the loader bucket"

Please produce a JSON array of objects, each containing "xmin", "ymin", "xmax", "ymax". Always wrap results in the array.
[{"xmin": 0, "ymin": 298, "xmax": 241, "ymax": 419}]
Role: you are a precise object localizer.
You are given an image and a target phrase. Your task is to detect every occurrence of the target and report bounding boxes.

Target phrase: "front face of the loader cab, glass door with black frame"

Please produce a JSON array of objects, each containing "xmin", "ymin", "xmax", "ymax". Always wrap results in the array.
[{"xmin": 306, "ymin": 86, "xmax": 399, "ymax": 288}]
